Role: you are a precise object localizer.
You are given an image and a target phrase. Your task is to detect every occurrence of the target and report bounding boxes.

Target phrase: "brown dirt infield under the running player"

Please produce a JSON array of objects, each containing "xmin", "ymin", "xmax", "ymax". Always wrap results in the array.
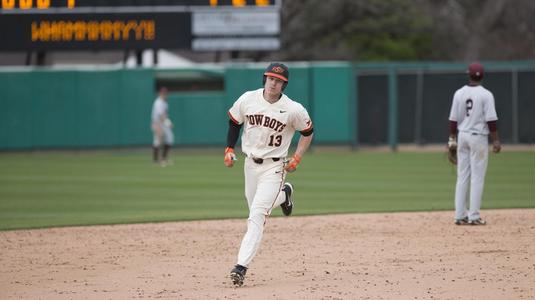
[{"xmin": 0, "ymin": 209, "xmax": 535, "ymax": 300}]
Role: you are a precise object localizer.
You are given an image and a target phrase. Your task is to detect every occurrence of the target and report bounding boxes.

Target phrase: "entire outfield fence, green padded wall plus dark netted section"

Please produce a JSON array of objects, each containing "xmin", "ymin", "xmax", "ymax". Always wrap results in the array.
[{"xmin": 0, "ymin": 61, "xmax": 535, "ymax": 150}]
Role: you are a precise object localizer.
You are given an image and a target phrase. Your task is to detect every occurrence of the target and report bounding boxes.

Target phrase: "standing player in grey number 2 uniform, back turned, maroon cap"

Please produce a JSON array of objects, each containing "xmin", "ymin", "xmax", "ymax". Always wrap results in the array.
[{"xmin": 448, "ymin": 63, "xmax": 501, "ymax": 225}]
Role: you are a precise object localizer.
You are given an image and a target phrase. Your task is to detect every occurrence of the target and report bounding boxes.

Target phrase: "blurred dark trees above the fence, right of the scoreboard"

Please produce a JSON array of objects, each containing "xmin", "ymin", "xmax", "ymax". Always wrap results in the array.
[{"xmin": 243, "ymin": 0, "xmax": 535, "ymax": 61}]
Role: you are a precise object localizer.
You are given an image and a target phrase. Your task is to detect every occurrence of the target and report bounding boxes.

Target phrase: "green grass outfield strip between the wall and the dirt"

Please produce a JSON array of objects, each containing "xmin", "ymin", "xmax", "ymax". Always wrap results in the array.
[{"xmin": 0, "ymin": 150, "xmax": 535, "ymax": 230}]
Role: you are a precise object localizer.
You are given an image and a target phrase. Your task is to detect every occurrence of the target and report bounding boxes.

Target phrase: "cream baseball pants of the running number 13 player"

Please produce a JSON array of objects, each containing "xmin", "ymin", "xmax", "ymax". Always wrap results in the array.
[{"xmin": 238, "ymin": 158, "xmax": 286, "ymax": 267}]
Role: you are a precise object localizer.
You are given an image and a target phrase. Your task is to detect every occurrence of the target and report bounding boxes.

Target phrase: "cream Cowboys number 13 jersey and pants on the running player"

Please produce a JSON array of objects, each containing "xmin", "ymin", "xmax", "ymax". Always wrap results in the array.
[{"xmin": 228, "ymin": 89, "xmax": 312, "ymax": 267}]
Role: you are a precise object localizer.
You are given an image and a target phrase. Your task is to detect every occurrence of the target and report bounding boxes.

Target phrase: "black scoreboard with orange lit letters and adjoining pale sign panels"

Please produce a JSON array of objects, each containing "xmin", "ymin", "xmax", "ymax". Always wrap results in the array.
[{"xmin": 0, "ymin": 0, "xmax": 281, "ymax": 51}]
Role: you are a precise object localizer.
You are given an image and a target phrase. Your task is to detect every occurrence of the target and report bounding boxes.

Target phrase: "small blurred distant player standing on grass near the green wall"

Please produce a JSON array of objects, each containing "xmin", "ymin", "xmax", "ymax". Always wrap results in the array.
[{"xmin": 151, "ymin": 87, "xmax": 174, "ymax": 167}]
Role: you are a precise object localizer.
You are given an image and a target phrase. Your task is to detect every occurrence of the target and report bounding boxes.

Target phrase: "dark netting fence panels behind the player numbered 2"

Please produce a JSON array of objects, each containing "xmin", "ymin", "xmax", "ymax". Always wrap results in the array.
[{"xmin": 357, "ymin": 70, "xmax": 535, "ymax": 145}]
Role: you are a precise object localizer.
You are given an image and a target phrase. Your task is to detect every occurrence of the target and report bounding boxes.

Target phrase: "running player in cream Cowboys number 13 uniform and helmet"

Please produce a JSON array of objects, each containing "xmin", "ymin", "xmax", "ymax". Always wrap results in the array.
[{"xmin": 224, "ymin": 63, "xmax": 313, "ymax": 286}]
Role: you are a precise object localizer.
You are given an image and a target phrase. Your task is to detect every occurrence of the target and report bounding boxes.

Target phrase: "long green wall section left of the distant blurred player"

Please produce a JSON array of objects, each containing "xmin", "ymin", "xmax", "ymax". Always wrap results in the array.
[{"xmin": 0, "ymin": 70, "xmax": 154, "ymax": 149}]
